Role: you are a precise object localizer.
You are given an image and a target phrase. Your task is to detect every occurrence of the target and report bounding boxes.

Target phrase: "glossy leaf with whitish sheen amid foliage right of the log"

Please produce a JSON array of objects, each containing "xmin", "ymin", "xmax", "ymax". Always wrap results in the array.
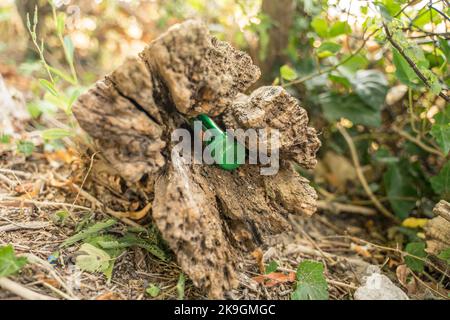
[{"xmin": 349, "ymin": 70, "xmax": 388, "ymax": 110}]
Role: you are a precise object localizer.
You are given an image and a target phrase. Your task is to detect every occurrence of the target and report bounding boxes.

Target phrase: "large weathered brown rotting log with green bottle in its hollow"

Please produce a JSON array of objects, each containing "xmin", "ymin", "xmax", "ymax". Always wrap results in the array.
[{"xmin": 73, "ymin": 21, "xmax": 320, "ymax": 298}]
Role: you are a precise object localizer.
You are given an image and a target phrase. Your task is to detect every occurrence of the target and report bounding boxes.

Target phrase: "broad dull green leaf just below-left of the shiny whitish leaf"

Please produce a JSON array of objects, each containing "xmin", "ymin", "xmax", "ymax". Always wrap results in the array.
[{"xmin": 319, "ymin": 93, "xmax": 381, "ymax": 127}]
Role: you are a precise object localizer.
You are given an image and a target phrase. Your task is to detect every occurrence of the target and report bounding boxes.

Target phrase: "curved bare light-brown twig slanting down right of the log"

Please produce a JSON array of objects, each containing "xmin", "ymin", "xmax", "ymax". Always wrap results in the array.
[{"xmin": 336, "ymin": 123, "xmax": 399, "ymax": 223}]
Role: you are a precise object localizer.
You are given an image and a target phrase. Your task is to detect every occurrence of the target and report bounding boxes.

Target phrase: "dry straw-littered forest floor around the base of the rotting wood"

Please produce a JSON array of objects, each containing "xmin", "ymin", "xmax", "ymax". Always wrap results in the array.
[{"xmin": 0, "ymin": 138, "xmax": 408, "ymax": 299}]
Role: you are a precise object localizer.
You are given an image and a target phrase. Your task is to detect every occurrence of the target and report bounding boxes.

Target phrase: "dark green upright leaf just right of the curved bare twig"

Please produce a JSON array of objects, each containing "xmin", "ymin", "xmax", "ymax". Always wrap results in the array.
[{"xmin": 383, "ymin": 160, "xmax": 418, "ymax": 219}]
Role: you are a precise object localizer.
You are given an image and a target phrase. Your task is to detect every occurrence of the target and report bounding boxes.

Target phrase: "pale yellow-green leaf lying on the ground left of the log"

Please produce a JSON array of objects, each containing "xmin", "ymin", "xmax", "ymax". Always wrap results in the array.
[{"xmin": 75, "ymin": 243, "xmax": 111, "ymax": 272}]
